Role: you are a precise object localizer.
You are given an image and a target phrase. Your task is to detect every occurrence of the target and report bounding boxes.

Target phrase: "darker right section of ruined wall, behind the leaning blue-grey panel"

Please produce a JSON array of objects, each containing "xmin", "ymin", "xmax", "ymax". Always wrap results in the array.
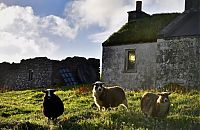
[{"xmin": 52, "ymin": 57, "xmax": 100, "ymax": 84}]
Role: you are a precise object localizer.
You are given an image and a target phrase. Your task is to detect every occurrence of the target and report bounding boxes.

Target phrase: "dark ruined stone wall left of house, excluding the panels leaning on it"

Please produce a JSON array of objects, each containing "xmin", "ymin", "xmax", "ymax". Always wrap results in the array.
[{"xmin": 0, "ymin": 57, "xmax": 100, "ymax": 89}]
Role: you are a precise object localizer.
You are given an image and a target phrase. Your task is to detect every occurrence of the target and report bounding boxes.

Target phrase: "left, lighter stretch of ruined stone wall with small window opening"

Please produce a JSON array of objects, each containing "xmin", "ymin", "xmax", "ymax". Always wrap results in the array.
[{"xmin": 0, "ymin": 57, "xmax": 52, "ymax": 89}]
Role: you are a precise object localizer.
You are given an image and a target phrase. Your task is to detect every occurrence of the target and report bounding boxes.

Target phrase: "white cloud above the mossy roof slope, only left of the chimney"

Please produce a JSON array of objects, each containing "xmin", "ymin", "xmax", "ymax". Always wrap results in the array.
[{"xmin": 65, "ymin": 0, "xmax": 132, "ymax": 42}]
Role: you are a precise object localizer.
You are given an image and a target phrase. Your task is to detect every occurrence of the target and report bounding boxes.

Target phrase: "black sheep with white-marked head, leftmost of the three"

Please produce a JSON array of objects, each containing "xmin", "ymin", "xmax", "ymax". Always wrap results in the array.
[{"xmin": 42, "ymin": 89, "xmax": 64, "ymax": 122}]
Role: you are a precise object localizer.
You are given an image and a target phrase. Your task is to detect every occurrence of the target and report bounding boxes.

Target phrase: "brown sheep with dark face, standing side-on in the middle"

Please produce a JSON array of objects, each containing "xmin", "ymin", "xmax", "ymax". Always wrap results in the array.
[{"xmin": 93, "ymin": 81, "xmax": 128, "ymax": 110}]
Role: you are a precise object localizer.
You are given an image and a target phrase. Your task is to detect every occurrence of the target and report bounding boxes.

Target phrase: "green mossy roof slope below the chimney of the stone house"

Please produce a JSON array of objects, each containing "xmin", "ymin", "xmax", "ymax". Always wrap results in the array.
[{"xmin": 103, "ymin": 13, "xmax": 179, "ymax": 46}]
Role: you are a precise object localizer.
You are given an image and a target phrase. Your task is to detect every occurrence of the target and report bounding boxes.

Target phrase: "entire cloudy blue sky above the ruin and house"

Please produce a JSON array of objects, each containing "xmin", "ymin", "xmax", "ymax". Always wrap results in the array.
[{"xmin": 0, "ymin": 0, "xmax": 184, "ymax": 62}]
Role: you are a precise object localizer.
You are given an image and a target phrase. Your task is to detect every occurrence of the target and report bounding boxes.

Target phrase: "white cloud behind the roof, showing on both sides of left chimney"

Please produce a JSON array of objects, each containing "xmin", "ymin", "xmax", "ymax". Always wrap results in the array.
[{"xmin": 65, "ymin": 0, "xmax": 184, "ymax": 43}]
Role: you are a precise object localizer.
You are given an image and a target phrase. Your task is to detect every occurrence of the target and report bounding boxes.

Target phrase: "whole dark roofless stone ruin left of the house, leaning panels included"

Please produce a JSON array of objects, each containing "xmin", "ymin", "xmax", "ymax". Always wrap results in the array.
[{"xmin": 0, "ymin": 57, "xmax": 100, "ymax": 89}]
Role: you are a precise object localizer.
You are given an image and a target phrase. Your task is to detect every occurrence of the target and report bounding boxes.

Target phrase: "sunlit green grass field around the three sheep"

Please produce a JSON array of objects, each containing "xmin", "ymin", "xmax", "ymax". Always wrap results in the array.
[{"xmin": 0, "ymin": 87, "xmax": 200, "ymax": 130}]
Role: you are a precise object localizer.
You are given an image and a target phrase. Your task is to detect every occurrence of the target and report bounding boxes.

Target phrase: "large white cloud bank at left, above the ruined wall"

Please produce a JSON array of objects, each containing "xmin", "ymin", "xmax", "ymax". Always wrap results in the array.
[{"xmin": 0, "ymin": 3, "xmax": 77, "ymax": 62}]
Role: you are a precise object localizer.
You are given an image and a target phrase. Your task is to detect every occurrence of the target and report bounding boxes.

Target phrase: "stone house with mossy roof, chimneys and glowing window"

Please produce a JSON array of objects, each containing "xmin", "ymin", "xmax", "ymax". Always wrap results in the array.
[{"xmin": 102, "ymin": 0, "xmax": 200, "ymax": 88}]
